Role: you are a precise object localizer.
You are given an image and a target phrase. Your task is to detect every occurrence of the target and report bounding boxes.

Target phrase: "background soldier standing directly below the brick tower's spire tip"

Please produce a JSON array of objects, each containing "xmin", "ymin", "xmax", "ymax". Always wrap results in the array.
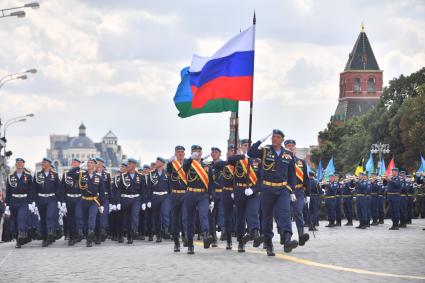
[{"xmin": 356, "ymin": 172, "xmax": 371, "ymax": 229}]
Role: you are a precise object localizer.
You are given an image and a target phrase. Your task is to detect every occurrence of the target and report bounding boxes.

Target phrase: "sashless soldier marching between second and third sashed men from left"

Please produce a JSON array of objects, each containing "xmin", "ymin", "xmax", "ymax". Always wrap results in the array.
[{"xmin": 209, "ymin": 147, "xmax": 224, "ymax": 248}]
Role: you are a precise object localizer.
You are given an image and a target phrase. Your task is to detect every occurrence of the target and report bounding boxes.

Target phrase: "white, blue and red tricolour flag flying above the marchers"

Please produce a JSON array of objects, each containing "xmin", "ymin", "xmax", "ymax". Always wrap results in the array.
[{"xmin": 189, "ymin": 25, "xmax": 255, "ymax": 108}]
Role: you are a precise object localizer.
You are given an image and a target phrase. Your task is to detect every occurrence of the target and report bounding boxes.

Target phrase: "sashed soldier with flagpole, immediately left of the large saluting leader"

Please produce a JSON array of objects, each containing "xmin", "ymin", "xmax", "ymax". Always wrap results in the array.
[{"xmin": 228, "ymin": 139, "xmax": 264, "ymax": 252}]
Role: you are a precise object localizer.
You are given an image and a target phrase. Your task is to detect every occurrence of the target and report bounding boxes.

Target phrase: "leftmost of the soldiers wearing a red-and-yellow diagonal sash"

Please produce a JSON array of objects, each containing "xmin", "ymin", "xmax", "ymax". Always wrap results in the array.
[{"xmin": 167, "ymin": 145, "xmax": 187, "ymax": 252}]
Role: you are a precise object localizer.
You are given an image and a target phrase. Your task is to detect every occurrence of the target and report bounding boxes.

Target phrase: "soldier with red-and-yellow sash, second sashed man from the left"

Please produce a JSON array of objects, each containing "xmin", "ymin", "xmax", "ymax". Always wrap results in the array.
[{"xmin": 183, "ymin": 145, "xmax": 214, "ymax": 254}]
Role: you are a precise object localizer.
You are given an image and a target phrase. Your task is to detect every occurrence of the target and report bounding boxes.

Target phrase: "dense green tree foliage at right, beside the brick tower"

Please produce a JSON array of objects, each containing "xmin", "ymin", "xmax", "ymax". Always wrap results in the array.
[{"xmin": 311, "ymin": 67, "xmax": 425, "ymax": 173}]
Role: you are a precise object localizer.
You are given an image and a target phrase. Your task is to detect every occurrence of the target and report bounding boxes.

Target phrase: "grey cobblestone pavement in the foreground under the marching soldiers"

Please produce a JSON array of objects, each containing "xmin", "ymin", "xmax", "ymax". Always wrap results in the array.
[{"xmin": 0, "ymin": 219, "xmax": 425, "ymax": 283}]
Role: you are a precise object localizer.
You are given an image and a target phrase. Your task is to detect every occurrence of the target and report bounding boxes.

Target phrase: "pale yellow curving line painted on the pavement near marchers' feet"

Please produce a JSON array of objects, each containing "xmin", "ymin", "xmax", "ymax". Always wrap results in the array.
[{"xmin": 195, "ymin": 242, "xmax": 425, "ymax": 280}]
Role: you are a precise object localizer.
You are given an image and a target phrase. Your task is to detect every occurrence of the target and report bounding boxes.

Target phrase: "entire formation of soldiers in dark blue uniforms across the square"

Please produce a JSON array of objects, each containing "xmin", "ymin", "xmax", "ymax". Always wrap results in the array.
[{"xmin": 5, "ymin": 130, "xmax": 424, "ymax": 256}]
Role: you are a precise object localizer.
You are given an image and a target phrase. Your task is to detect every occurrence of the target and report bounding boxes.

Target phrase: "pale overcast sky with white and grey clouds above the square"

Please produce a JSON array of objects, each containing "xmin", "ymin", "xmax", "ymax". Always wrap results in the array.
[{"xmin": 0, "ymin": 0, "xmax": 425, "ymax": 168}]
